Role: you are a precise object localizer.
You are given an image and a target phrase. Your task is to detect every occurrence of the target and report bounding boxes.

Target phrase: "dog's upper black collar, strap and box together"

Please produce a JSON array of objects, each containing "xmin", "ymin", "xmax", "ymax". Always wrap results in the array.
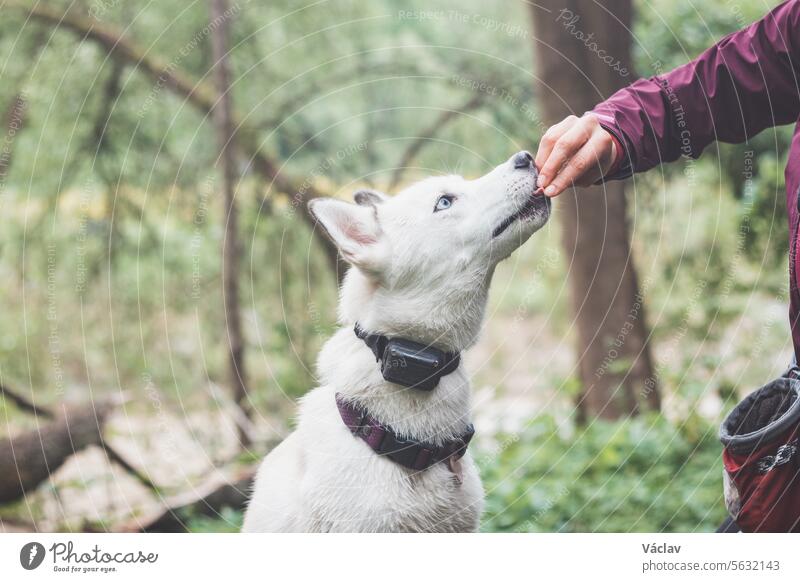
[{"xmin": 354, "ymin": 323, "xmax": 461, "ymax": 390}]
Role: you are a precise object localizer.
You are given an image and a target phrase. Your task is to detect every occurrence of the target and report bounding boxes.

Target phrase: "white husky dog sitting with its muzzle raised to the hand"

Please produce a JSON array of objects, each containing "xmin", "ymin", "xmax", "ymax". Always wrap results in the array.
[{"xmin": 243, "ymin": 152, "xmax": 550, "ymax": 532}]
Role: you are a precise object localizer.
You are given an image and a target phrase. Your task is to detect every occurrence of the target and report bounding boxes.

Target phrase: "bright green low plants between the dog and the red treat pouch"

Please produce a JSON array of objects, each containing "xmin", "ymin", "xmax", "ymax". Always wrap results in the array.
[{"xmin": 477, "ymin": 416, "xmax": 725, "ymax": 532}]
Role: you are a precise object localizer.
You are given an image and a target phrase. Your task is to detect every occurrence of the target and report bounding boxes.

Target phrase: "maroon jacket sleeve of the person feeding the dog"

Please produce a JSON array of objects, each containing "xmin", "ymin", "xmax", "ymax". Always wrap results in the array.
[{"xmin": 593, "ymin": 0, "xmax": 800, "ymax": 178}]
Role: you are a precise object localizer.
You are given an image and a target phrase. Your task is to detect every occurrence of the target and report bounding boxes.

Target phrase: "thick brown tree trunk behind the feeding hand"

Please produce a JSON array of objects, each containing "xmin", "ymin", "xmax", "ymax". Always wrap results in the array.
[{"xmin": 531, "ymin": 0, "xmax": 660, "ymax": 418}]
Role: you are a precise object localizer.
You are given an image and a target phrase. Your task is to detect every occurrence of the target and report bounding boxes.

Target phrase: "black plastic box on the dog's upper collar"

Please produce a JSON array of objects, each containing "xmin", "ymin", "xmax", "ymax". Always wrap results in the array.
[{"xmin": 381, "ymin": 338, "xmax": 446, "ymax": 390}]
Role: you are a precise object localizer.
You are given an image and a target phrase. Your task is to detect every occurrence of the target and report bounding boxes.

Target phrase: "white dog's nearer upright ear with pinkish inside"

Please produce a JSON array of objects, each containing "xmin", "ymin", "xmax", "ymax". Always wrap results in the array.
[{"xmin": 308, "ymin": 198, "xmax": 388, "ymax": 278}]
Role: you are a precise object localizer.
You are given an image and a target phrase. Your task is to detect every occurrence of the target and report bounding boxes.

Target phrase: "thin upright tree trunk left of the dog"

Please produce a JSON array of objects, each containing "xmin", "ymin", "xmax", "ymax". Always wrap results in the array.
[{"xmin": 211, "ymin": 0, "xmax": 249, "ymax": 446}]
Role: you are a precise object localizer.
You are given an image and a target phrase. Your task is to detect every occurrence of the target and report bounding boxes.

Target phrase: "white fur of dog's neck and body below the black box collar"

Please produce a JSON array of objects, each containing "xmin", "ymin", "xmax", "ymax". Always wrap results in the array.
[{"xmin": 244, "ymin": 330, "xmax": 483, "ymax": 532}]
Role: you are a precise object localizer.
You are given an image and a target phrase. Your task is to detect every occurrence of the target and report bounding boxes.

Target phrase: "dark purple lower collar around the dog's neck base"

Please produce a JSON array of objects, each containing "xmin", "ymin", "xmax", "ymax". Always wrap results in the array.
[{"xmin": 336, "ymin": 393, "xmax": 475, "ymax": 471}]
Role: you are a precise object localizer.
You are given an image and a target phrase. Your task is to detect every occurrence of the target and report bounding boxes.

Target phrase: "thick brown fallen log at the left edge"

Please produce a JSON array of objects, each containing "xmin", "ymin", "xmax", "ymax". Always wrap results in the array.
[{"xmin": 0, "ymin": 399, "xmax": 119, "ymax": 503}]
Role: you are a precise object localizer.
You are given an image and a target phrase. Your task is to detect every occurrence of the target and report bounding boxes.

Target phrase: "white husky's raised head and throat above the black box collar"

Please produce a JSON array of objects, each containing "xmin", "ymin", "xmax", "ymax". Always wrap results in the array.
[{"xmin": 309, "ymin": 152, "xmax": 550, "ymax": 349}]
